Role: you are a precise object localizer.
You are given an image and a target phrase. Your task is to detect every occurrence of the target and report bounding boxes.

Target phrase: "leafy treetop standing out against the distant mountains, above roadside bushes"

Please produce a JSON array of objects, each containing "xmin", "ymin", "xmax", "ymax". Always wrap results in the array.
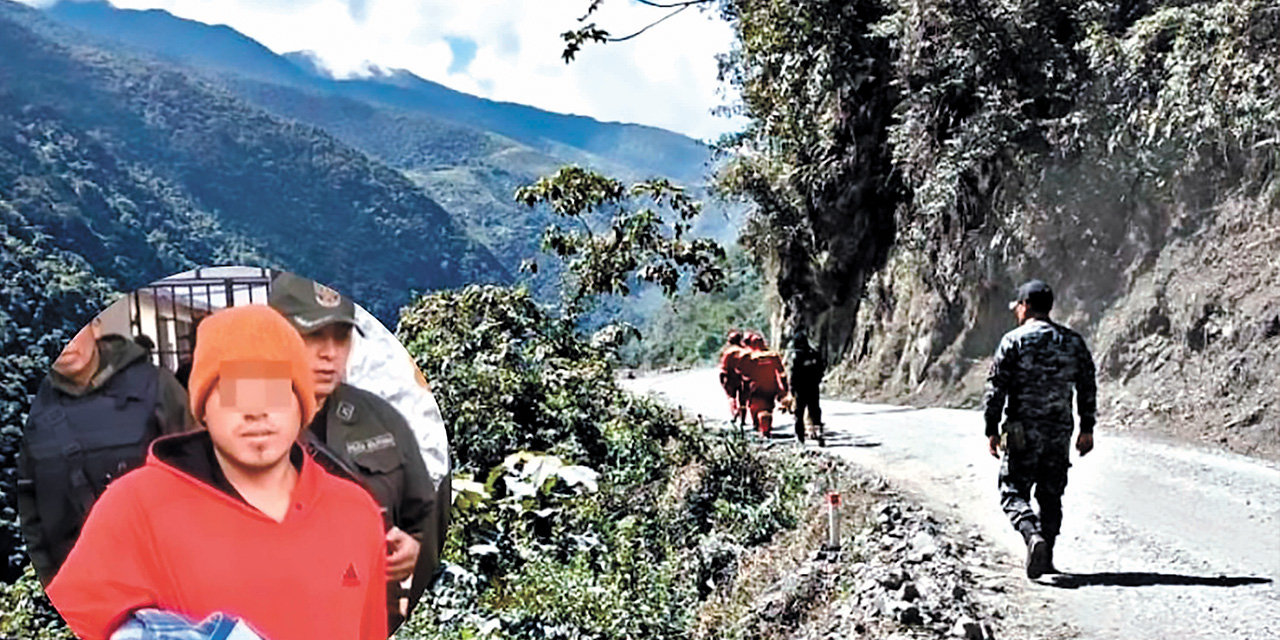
[{"xmin": 516, "ymin": 166, "xmax": 724, "ymax": 317}]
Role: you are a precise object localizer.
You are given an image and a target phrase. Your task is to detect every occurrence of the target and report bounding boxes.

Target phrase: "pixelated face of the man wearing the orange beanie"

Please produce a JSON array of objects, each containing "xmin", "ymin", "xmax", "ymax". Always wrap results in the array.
[{"xmin": 205, "ymin": 376, "xmax": 302, "ymax": 474}]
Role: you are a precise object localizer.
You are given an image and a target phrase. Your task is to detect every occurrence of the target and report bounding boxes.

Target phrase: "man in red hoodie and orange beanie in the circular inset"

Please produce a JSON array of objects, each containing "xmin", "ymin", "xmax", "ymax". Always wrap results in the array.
[{"xmin": 47, "ymin": 305, "xmax": 387, "ymax": 640}]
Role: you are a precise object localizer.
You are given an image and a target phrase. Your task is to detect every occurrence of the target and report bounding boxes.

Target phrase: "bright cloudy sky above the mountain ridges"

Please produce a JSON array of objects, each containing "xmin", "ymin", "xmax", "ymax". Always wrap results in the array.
[{"xmin": 22, "ymin": 0, "xmax": 742, "ymax": 140}]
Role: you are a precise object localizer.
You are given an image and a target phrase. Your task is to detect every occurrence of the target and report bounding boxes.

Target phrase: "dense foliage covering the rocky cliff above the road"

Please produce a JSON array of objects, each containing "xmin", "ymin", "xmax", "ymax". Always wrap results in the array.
[{"xmin": 568, "ymin": 0, "xmax": 1280, "ymax": 366}]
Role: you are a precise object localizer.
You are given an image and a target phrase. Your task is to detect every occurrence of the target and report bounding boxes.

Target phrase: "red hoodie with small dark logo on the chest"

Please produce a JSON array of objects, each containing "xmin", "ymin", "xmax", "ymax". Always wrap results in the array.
[{"xmin": 47, "ymin": 431, "xmax": 388, "ymax": 640}]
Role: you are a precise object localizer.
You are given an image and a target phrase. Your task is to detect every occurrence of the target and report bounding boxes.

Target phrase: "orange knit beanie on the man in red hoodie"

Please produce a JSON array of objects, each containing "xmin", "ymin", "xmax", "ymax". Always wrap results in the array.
[{"xmin": 188, "ymin": 305, "xmax": 316, "ymax": 425}]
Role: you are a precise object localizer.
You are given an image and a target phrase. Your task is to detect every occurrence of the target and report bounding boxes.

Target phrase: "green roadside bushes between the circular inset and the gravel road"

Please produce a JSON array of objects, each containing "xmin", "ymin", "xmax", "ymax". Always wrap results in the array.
[{"xmin": 398, "ymin": 287, "xmax": 813, "ymax": 640}]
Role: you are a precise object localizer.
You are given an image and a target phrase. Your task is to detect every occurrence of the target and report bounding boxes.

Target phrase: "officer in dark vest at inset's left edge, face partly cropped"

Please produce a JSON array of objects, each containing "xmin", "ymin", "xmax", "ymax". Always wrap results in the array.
[{"xmin": 17, "ymin": 317, "xmax": 195, "ymax": 585}]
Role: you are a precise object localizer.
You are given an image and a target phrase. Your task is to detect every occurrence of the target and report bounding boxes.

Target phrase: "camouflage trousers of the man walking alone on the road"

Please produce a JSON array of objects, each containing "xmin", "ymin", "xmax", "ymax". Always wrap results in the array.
[{"xmin": 1000, "ymin": 424, "xmax": 1071, "ymax": 540}]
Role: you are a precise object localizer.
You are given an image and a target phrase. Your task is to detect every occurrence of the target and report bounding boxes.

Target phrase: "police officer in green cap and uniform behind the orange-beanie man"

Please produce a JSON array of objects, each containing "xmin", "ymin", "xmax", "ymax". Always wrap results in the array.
[{"xmin": 268, "ymin": 273, "xmax": 448, "ymax": 630}]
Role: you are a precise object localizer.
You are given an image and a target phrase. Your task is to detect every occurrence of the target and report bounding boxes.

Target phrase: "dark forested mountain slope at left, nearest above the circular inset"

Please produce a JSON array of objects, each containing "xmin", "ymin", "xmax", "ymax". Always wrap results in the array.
[{"xmin": 0, "ymin": 1, "xmax": 508, "ymax": 323}]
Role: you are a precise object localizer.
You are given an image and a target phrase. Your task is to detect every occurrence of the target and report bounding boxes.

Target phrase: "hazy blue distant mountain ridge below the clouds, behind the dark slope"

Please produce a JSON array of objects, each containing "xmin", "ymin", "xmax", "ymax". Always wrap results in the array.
[{"xmin": 40, "ymin": 1, "xmax": 741, "ymax": 298}]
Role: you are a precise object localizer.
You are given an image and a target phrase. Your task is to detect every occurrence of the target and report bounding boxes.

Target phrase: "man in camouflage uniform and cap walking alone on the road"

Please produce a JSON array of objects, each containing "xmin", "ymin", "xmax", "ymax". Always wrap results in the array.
[{"xmin": 983, "ymin": 280, "xmax": 1097, "ymax": 580}]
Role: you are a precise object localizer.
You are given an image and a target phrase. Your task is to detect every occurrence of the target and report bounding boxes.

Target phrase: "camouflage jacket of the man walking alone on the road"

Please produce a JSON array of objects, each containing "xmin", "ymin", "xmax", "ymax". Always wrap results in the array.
[{"xmin": 983, "ymin": 319, "xmax": 1098, "ymax": 435}]
